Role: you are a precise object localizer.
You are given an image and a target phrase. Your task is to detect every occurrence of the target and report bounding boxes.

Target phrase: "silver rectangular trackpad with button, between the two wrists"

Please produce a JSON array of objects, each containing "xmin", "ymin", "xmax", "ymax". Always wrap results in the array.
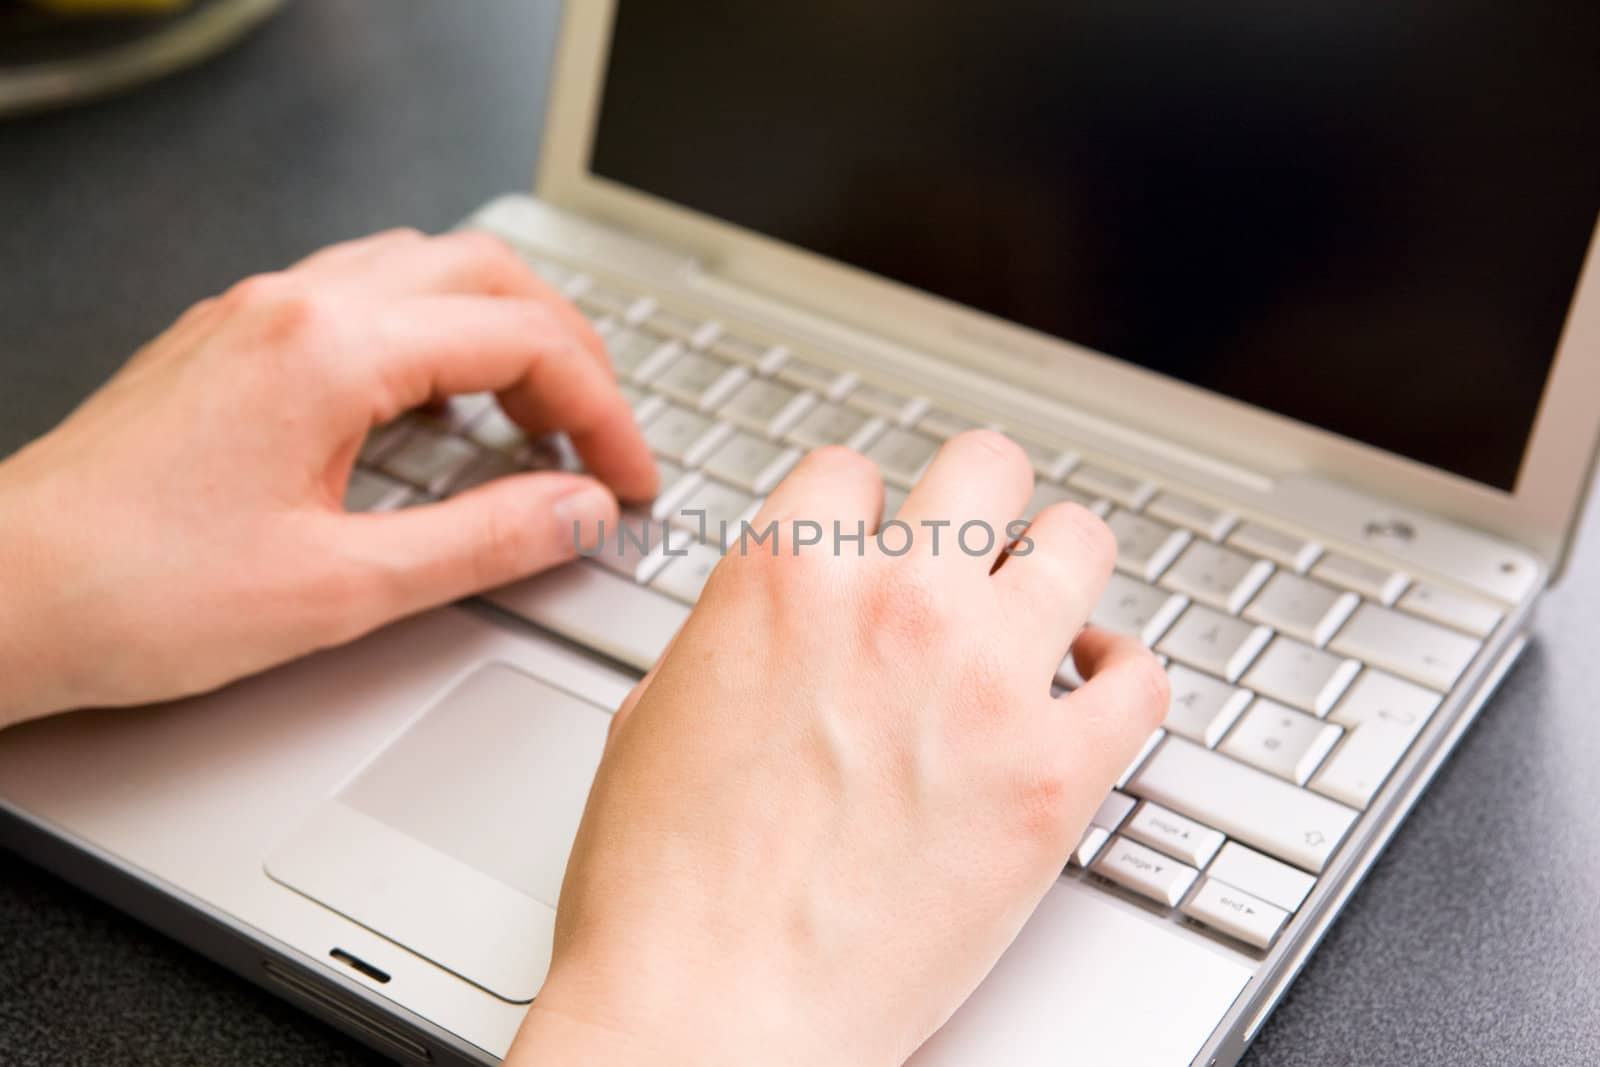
[{"xmin": 267, "ymin": 662, "xmax": 611, "ymax": 1003}]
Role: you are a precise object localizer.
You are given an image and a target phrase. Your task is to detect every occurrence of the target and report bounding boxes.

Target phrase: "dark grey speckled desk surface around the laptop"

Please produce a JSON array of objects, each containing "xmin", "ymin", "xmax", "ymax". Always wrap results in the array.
[{"xmin": 0, "ymin": 0, "xmax": 1600, "ymax": 1067}]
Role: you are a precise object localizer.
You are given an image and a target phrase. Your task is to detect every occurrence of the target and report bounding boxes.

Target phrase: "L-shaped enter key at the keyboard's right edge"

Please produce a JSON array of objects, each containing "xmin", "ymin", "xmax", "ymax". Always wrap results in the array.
[{"xmin": 1310, "ymin": 670, "xmax": 1438, "ymax": 808}]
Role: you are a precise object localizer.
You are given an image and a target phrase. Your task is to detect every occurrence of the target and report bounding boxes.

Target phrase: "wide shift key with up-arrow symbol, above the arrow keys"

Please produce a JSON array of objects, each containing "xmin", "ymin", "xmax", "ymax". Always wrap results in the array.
[{"xmin": 1128, "ymin": 739, "xmax": 1355, "ymax": 870}]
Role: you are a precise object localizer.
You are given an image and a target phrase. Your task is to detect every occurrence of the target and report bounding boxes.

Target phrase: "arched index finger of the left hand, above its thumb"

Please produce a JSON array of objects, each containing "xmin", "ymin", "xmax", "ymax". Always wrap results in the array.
[{"xmin": 363, "ymin": 296, "xmax": 656, "ymax": 501}]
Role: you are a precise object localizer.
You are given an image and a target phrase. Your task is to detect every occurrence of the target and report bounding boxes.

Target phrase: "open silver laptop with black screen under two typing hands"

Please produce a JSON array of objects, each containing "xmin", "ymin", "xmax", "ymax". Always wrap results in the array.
[{"xmin": 0, "ymin": 0, "xmax": 1600, "ymax": 1067}]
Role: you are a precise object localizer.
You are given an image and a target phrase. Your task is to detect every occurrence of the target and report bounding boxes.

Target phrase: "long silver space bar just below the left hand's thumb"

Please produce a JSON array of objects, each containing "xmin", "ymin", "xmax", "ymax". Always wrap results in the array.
[{"xmin": 485, "ymin": 560, "xmax": 690, "ymax": 670}]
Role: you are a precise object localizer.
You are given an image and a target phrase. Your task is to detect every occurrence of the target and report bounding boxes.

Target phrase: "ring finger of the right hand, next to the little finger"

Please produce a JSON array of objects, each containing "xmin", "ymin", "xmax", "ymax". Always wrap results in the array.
[{"xmin": 992, "ymin": 501, "xmax": 1117, "ymax": 665}]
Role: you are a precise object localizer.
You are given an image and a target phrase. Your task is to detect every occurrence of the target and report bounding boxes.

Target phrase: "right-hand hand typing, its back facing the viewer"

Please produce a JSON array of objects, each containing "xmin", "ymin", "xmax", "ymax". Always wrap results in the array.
[{"xmin": 507, "ymin": 430, "xmax": 1166, "ymax": 1067}]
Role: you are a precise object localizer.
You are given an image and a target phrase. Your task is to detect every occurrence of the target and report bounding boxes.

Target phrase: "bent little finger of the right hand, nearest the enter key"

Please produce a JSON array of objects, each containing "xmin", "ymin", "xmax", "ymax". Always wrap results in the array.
[{"xmin": 1054, "ymin": 625, "xmax": 1171, "ymax": 777}]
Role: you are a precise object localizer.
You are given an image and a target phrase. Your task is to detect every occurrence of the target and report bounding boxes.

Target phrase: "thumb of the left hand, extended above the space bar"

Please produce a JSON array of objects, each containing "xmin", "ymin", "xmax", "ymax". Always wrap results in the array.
[{"xmin": 339, "ymin": 472, "xmax": 618, "ymax": 627}]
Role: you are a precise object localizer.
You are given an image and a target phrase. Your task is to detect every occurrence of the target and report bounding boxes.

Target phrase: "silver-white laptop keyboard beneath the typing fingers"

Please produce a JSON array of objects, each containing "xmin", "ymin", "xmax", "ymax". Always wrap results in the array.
[{"xmin": 346, "ymin": 261, "xmax": 1502, "ymax": 950}]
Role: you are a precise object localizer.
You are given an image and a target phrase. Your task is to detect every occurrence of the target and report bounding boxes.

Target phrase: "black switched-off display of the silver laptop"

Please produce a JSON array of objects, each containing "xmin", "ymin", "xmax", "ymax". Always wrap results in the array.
[{"xmin": 592, "ymin": 0, "xmax": 1600, "ymax": 490}]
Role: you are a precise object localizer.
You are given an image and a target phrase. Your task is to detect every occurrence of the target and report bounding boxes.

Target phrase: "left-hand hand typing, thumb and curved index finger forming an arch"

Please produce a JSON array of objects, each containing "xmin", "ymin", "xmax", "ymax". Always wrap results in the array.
[{"xmin": 0, "ymin": 225, "xmax": 656, "ymax": 726}]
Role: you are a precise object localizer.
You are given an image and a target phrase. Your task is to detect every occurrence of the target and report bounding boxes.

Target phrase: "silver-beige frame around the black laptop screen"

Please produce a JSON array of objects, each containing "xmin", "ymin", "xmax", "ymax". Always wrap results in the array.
[{"xmin": 534, "ymin": 0, "xmax": 1600, "ymax": 569}]
